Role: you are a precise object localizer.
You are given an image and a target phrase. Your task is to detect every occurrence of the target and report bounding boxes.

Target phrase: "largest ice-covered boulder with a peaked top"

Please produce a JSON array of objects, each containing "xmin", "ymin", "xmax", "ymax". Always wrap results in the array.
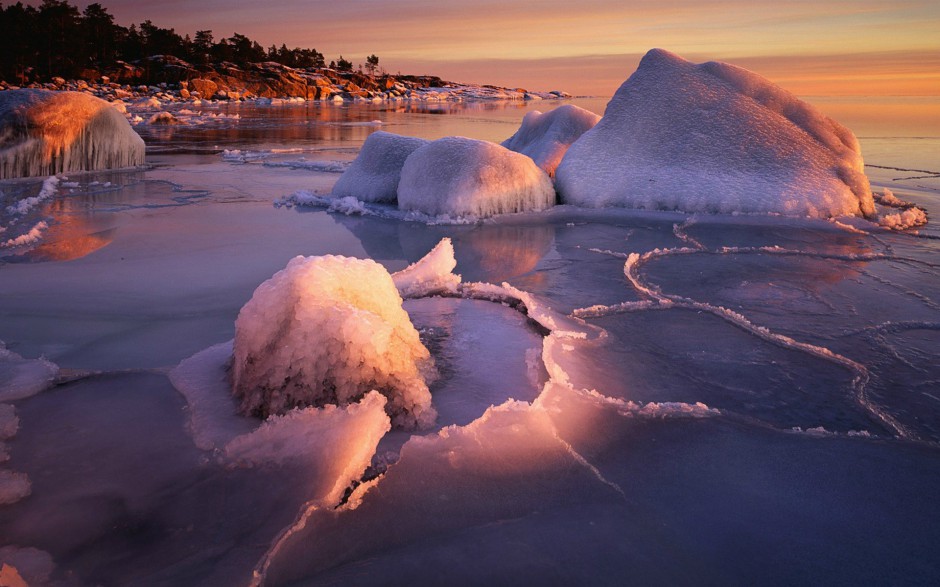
[{"xmin": 555, "ymin": 49, "xmax": 875, "ymax": 217}]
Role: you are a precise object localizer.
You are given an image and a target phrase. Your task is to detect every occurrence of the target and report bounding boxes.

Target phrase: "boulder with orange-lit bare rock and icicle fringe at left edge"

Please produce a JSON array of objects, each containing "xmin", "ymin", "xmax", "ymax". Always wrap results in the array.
[{"xmin": 0, "ymin": 90, "xmax": 144, "ymax": 179}]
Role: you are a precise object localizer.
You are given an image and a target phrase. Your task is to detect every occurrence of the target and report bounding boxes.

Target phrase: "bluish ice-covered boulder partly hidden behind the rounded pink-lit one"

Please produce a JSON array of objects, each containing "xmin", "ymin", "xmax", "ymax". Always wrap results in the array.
[{"xmin": 333, "ymin": 131, "xmax": 428, "ymax": 202}]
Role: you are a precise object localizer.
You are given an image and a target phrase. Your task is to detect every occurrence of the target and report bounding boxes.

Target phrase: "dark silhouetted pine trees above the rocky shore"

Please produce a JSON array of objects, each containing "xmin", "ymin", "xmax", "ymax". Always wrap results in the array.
[{"xmin": 0, "ymin": 0, "xmax": 379, "ymax": 84}]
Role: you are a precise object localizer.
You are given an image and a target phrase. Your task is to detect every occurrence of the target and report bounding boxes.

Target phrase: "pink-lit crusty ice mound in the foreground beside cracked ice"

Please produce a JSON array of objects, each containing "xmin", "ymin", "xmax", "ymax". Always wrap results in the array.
[{"xmin": 233, "ymin": 255, "xmax": 436, "ymax": 428}]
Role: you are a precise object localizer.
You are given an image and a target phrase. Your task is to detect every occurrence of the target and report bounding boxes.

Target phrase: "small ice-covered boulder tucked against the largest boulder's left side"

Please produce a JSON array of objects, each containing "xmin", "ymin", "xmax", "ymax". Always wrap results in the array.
[{"xmin": 502, "ymin": 104, "xmax": 601, "ymax": 176}]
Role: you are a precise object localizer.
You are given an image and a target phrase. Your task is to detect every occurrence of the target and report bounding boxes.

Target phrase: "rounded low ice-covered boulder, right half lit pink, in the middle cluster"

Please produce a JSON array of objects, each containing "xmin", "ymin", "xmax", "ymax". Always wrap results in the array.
[{"xmin": 398, "ymin": 137, "xmax": 555, "ymax": 217}]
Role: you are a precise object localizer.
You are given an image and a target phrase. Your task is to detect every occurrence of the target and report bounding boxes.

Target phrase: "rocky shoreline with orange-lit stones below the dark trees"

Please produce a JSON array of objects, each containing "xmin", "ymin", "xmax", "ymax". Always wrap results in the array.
[{"xmin": 0, "ymin": 55, "xmax": 571, "ymax": 103}]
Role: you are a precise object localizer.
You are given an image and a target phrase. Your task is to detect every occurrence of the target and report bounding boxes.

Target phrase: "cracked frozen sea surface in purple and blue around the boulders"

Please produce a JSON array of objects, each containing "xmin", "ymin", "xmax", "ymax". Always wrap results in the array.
[{"xmin": 0, "ymin": 94, "xmax": 940, "ymax": 585}]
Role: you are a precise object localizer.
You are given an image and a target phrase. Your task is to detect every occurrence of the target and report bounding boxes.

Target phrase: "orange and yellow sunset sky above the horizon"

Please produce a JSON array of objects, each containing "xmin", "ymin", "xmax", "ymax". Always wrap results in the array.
[{"xmin": 73, "ymin": 0, "xmax": 940, "ymax": 96}]
